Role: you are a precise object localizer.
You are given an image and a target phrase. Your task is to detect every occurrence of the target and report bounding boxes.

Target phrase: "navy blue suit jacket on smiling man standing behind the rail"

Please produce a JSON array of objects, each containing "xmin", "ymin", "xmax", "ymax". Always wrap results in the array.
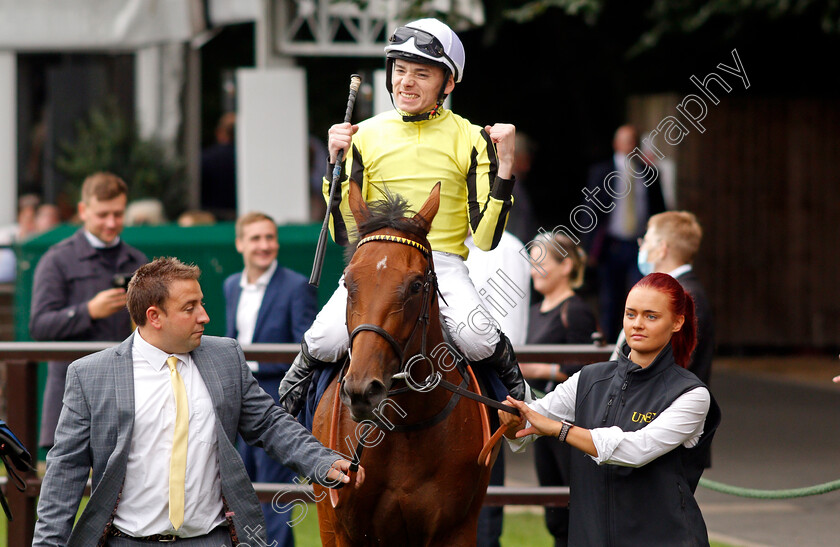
[{"xmin": 224, "ymin": 266, "xmax": 318, "ymax": 390}]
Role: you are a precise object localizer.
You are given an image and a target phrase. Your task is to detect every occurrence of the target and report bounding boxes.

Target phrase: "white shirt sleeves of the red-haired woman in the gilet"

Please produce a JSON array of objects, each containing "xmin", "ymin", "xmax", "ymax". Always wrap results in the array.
[{"xmin": 508, "ymin": 372, "xmax": 711, "ymax": 467}]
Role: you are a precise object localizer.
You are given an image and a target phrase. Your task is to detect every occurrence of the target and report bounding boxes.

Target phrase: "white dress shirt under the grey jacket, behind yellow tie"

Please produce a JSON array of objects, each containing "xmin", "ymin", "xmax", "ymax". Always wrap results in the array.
[{"xmin": 114, "ymin": 329, "xmax": 225, "ymax": 537}]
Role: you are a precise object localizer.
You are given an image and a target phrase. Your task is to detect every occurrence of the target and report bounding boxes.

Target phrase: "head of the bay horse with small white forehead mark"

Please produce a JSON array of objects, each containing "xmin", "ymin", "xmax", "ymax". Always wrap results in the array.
[{"xmin": 340, "ymin": 183, "xmax": 440, "ymax": 421}]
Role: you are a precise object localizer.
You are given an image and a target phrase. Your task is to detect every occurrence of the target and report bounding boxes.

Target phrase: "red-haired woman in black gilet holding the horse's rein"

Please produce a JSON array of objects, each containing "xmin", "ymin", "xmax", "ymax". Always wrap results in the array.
[{"xmin": 500, "ymin": 273, "xmax": 720, "ymax": 546}]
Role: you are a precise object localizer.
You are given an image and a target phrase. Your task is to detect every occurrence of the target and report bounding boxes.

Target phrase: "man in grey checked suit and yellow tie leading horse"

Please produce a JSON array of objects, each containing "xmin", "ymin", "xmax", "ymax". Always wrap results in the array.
[{"xmin": 33, "ymin": 258, "xmax": 364, "ymax": 547}]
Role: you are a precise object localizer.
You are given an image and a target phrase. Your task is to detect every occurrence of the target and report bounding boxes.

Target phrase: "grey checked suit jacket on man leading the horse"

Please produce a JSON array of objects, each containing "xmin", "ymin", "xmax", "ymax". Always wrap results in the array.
[{"xmin": 33, "ymin": 334, "xmax": 341, "ymax": 547}]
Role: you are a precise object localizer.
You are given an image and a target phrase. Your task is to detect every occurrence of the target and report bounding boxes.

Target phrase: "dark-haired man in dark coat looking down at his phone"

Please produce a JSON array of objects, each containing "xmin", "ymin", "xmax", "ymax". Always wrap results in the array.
[{"xmin": 29, "ymin": 173, "xmax": 148, "ymax": 448}]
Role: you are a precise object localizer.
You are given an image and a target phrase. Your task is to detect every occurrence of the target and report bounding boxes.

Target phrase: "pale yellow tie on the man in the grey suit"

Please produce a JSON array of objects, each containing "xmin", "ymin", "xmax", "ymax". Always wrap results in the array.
[{"xmin": 166, "ymin": 355, "xmax": 190, "ymax": 530}]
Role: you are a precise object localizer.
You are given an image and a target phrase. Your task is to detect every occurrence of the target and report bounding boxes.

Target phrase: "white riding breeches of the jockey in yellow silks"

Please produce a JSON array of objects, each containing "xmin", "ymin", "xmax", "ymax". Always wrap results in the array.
[{"xmin": 303, "ymin": 251, "xmax": 500, "ymax": 362}]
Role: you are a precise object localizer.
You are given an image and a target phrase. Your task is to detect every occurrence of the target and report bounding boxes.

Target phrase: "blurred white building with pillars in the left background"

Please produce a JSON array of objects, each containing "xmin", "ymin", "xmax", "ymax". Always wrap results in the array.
[{"xmin": 0, "ymin": 0, "xmax": 483, "ymax": 225}]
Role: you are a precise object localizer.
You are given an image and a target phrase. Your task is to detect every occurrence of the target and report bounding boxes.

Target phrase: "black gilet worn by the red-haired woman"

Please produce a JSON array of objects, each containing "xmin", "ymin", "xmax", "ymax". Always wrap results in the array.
[{"xmin": 569, "ymin": 344, "xmax": 720, "ymax": 547}]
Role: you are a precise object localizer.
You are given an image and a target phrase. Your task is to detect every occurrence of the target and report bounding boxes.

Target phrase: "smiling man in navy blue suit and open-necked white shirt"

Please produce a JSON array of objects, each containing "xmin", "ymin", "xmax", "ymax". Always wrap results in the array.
[{"xmin": 224, "ymin": 212, "xmax": 318, "ymax": 547}]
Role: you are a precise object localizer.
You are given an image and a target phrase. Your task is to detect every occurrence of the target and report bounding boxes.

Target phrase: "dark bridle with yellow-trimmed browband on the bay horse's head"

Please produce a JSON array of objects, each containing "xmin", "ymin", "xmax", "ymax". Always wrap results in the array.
[{"xmin": 350, "ymin": 234, "xmax": 439, "ymax": 386}]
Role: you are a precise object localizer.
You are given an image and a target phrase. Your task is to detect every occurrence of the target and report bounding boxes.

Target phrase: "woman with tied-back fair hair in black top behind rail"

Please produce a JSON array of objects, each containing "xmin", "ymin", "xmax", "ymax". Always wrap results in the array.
[{"xmin": 520, "ymin": 233, "xmax": 597, "ymax": 547}]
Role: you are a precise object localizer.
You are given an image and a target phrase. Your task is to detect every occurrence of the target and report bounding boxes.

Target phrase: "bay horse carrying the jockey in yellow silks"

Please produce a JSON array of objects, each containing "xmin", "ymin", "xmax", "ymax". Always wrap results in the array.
[{"xmin": 313, "ymin": 183, "xmax": 499, "ymax": 547}]
